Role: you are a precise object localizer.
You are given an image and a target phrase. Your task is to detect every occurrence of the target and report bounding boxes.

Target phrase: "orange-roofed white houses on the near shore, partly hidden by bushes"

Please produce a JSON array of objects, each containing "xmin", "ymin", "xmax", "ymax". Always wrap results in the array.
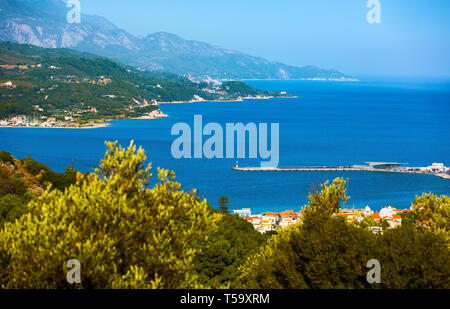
[{"xmin": 233, "ymin": 206, "xmax": 412, "ymax": 233}]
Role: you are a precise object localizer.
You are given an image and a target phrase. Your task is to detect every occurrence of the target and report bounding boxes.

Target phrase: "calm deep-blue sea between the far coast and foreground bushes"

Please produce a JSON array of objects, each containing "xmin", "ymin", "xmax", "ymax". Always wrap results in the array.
[{"xmin": 0, "ymin": 81, "xmax": 450, "ymax": 213}]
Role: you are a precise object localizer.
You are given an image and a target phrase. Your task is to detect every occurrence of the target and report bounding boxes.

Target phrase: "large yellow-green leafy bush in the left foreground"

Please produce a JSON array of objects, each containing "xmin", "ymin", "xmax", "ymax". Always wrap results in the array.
[{"xmin": 0, "ymin": 143, "xmax": 219, "ymax": 288}]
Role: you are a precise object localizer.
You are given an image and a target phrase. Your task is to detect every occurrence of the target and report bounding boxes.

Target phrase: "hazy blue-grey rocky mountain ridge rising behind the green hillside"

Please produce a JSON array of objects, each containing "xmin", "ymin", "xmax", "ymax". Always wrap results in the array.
[{"xmin": 0, "ymin": 0, "xmax": 348, "ymax": 80}]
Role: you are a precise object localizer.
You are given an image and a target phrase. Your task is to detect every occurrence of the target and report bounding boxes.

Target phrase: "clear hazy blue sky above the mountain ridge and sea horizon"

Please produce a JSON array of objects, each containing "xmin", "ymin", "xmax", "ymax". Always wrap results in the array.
[{"xmin": 80, "ymin": 0, "xmax": 450, "ymax": 77}]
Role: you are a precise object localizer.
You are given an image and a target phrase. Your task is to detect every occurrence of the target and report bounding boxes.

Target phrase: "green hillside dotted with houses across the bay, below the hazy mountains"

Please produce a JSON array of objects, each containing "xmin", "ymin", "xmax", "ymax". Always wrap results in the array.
[{"xmin": 0, "ymin": 43, "xmax": 286, "ymax": 121}]
